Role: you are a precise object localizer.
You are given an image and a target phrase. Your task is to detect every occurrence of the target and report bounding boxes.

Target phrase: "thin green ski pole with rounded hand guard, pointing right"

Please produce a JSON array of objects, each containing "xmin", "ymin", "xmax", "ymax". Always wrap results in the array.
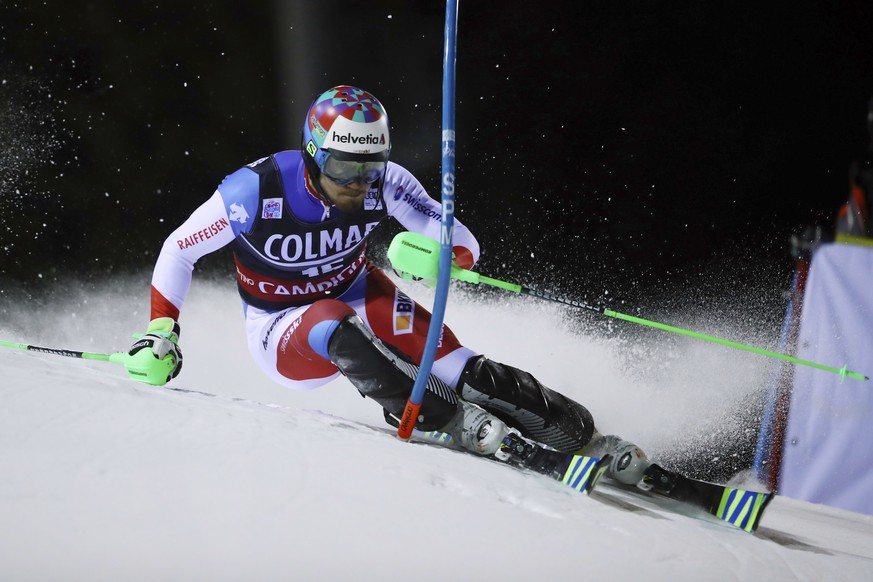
[{"xmin": 388, "ymin": 232, "xmax": 869, "ymax": 380}]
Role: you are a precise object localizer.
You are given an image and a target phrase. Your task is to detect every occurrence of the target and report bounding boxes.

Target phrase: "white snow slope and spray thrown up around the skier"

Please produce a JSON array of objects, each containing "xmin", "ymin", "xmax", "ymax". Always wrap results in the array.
[{"xmin": 0, "ymin": 278, "xmax": 873, "ymax": 582}]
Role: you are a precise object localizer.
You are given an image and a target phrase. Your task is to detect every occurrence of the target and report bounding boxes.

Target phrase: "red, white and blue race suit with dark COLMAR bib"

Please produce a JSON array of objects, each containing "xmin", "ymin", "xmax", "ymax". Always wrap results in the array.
[{"xmin": 151, "ymin": 151, "xmax": 479, "ymax": 389}]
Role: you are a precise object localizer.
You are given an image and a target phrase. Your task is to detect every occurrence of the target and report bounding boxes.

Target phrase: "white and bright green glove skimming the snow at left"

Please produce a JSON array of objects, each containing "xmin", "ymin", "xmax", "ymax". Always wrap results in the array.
[{"xmin": 124, "ymin": 317, "xmax": 182, "ymax": 386}]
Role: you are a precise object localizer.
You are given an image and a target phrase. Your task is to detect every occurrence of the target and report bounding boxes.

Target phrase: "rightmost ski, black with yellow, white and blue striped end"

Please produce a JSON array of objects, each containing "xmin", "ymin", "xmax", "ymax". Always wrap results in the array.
[{"xmin": 637, "ymin": 463, "xmax": 774, "ymax": 533}]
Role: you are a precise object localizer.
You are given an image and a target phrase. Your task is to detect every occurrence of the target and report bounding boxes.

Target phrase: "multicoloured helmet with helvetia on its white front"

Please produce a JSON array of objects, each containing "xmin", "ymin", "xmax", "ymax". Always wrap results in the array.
[{"xmin": 303, "ymin": 85, "xmax": 391, "ymax": 178}]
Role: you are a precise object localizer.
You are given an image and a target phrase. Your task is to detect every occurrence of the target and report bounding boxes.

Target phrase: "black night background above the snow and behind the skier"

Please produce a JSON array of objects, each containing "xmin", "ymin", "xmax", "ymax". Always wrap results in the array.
[{"xmin": 0, "ymin": 0, "xmax": 873, "ymax": 315}]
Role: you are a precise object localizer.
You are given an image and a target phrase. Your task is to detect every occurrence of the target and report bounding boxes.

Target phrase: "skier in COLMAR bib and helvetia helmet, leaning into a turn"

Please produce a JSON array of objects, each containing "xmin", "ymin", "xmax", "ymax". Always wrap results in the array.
[{"xmin": 127, "ymin": 86, "xmax": 649, "ymax": 484}]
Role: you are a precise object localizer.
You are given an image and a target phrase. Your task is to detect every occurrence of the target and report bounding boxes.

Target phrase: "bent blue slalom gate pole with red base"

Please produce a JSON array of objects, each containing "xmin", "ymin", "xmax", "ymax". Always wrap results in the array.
[{"xmin": 397, "ymin": 0, "xmax": 458, "ymax": 440}]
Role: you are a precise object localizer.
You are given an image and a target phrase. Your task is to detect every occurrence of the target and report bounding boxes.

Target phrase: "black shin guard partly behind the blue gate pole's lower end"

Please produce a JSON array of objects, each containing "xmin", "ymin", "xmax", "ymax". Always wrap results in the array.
[{"xmin": 327, "ymin": 315, "xmax": 458, "ymax": 430}]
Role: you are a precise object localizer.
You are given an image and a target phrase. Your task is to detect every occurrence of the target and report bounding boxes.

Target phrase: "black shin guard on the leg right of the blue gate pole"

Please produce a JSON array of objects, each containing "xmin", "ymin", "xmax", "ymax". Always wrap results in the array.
[{"xmin": 457, "ymin": 356, "xmax": 594, "ymax": 452}]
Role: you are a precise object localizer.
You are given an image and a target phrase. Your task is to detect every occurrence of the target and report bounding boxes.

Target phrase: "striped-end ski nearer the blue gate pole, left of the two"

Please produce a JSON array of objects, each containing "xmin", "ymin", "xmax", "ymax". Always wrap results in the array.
[{"xmin": 415, "ymin": 431, "xmax": 611, "ymax": 495}]
